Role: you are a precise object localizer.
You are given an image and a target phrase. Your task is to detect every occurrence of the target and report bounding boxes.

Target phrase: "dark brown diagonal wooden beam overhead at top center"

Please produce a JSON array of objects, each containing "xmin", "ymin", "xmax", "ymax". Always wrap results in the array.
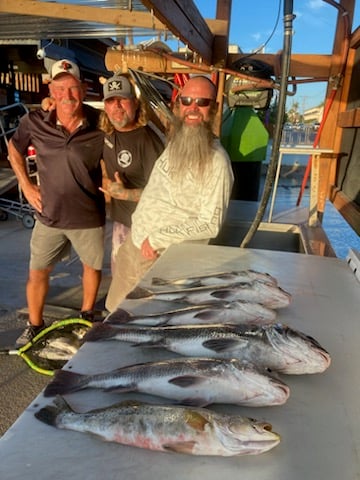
[{"xmin": 142, "ymin": 0, "xmax": 214, "ymax": 65}]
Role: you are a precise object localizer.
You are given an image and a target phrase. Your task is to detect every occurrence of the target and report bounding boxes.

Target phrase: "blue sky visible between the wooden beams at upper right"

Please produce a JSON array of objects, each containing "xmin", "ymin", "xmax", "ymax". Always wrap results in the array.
[{"xmin": 188, "ymin": 0, "xmax": 360, "ymax": 113}]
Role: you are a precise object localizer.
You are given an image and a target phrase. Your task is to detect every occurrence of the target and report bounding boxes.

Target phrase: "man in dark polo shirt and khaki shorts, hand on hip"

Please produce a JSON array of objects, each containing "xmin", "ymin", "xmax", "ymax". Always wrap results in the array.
[{"xmin": 9, "ymin": 60, "xmax": 105, "ymax": 346}]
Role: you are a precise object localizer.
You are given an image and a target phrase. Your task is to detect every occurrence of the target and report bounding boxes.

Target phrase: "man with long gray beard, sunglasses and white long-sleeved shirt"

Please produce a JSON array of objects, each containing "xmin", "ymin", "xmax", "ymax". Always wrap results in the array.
[{"xmin": 106, "ymin": 76, "xmax": 233, "ymax": 312}]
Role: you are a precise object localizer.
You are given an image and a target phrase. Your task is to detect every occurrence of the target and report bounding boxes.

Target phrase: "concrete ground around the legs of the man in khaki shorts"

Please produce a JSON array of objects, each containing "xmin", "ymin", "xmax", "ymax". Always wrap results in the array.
[{"xmin": 0, "ymin": 215, "xmax": 111, "ymax": 436}]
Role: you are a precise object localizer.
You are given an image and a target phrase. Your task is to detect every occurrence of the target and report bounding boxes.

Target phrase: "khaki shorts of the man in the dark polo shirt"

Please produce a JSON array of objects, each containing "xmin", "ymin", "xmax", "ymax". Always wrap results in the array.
[{"xmin": 30, "ymin": 221, "xmax": 105, "ymax": 270}]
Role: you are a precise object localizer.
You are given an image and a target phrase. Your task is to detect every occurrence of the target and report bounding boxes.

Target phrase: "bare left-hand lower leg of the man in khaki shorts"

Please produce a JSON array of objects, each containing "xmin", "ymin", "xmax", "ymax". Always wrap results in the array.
[{"xmin": 26, "ymin": 267, "xmax": 52, "ymax": 326}]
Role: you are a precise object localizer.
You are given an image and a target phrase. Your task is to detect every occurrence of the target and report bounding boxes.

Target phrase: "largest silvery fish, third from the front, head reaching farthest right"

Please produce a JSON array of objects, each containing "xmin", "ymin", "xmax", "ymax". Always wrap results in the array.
[{"xmin": 84, "ymin": 323, "xmax": 331, "ymax": 375}]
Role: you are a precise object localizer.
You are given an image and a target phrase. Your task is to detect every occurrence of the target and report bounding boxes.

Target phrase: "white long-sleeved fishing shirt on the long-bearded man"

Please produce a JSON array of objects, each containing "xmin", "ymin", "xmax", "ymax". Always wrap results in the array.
[{"xmin": 132, "ymin": 140, "xmax": 233, "ymax": 250}]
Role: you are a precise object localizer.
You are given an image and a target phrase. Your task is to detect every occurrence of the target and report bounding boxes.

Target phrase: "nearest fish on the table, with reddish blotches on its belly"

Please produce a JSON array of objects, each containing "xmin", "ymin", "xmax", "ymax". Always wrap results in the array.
[{"xmin": 34, "ymin": 396, "xmax": 281, "ymax": 457}]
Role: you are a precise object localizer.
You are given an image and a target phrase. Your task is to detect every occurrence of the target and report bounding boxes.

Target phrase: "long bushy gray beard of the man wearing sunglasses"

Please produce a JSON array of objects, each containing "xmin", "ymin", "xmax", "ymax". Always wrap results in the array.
[{"xmin": 168, "ymin": 119, "xmax": 214, "ymax": 180}]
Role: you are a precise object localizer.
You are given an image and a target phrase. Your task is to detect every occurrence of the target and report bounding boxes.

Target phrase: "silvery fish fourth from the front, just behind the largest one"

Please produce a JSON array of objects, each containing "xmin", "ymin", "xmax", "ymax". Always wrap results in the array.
[{"xmin": 106, "ymin": 300, "xmax": 277, "ymax": 327}]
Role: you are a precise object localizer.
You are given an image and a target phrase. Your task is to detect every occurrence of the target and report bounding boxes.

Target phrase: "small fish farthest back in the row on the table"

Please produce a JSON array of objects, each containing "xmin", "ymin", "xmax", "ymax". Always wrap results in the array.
[{"xmin": 151, "ymin": 269, "xmax": 278, "ymax": 287}]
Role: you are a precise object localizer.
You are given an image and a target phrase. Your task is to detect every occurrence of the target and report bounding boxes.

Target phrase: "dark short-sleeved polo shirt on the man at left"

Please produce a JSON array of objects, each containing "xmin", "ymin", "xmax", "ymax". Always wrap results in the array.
[{"xmin": 12, "ymin": 105, "xmax": 105, "ymax": 229}]
